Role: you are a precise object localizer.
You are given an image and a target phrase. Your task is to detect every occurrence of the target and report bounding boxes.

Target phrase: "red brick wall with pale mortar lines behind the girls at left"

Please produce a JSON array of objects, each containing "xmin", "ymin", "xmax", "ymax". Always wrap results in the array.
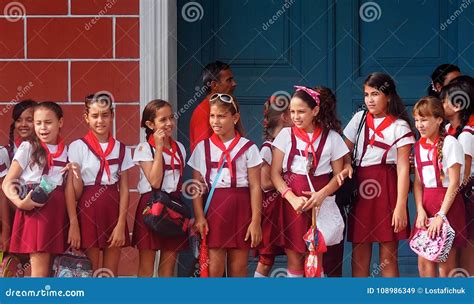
[{"xmin": 0, "ymin": 0, "xmax": 140, "ymax": 275}]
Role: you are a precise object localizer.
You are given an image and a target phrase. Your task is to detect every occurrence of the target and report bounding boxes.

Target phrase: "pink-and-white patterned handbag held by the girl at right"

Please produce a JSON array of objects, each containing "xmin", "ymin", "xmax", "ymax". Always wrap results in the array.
[{"xmin": 410, "ymin": 217, "xmax": 456, "ymax": 263}]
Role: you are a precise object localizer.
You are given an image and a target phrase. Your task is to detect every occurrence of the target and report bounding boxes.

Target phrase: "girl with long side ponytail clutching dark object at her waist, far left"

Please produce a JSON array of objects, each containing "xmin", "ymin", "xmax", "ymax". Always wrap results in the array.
[{"xmin": 2, "ymin": 102, "xmax": 76, "ymax": 277}]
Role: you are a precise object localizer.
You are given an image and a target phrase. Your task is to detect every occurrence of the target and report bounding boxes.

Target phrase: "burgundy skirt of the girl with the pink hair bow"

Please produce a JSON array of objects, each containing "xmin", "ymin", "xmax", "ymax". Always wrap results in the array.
[{"xmin": 277, "ymin": 172, "xmax": 330, "ymax": 253}]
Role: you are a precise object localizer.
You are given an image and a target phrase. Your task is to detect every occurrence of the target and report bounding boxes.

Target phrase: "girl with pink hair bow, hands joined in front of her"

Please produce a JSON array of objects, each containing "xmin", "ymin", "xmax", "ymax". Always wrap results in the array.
[{"xmin": 271, "ymin": 86, "xmax": 349, "ymax": 277}]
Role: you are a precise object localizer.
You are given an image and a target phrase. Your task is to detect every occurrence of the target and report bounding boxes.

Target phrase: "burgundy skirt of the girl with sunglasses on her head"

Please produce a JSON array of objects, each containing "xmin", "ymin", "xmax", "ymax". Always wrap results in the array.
[{"xmin": 206, "ymin": 188, "xmax": 252, "ymax": 249}]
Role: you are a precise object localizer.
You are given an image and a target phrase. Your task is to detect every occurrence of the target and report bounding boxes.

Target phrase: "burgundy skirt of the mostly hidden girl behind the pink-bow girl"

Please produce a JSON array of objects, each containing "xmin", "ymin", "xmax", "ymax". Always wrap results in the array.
[{"xmin": 256, "ymin": 190, "xmax": 285, "ymax": 256}]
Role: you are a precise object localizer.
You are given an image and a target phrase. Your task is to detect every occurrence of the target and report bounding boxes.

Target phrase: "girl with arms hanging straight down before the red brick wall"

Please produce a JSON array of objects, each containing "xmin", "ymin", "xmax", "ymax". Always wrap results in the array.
[{"xmin": 69, "ymin": 94, "xmax": 134, "ymax": 276}]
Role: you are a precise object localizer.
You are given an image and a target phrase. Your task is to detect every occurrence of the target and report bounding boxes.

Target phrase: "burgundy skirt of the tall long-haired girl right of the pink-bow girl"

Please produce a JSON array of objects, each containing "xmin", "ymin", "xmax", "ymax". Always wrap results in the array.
[{"xmin": 348, "ymin": 165, "xmax": 410, "ymax": 243}]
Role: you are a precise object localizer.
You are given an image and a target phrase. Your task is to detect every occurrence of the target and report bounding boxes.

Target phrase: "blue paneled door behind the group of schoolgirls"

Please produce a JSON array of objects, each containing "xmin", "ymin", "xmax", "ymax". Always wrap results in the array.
[{"xmin": 177, "ymin": 0, "xmax": 474, "ymax": 276}]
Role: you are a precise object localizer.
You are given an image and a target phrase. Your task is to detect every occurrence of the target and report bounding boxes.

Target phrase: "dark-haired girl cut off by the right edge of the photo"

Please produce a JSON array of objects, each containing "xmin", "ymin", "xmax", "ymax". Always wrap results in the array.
[{"xmin": 440, "ymin": 76, "xmax": 474, "ymax": 275}]
